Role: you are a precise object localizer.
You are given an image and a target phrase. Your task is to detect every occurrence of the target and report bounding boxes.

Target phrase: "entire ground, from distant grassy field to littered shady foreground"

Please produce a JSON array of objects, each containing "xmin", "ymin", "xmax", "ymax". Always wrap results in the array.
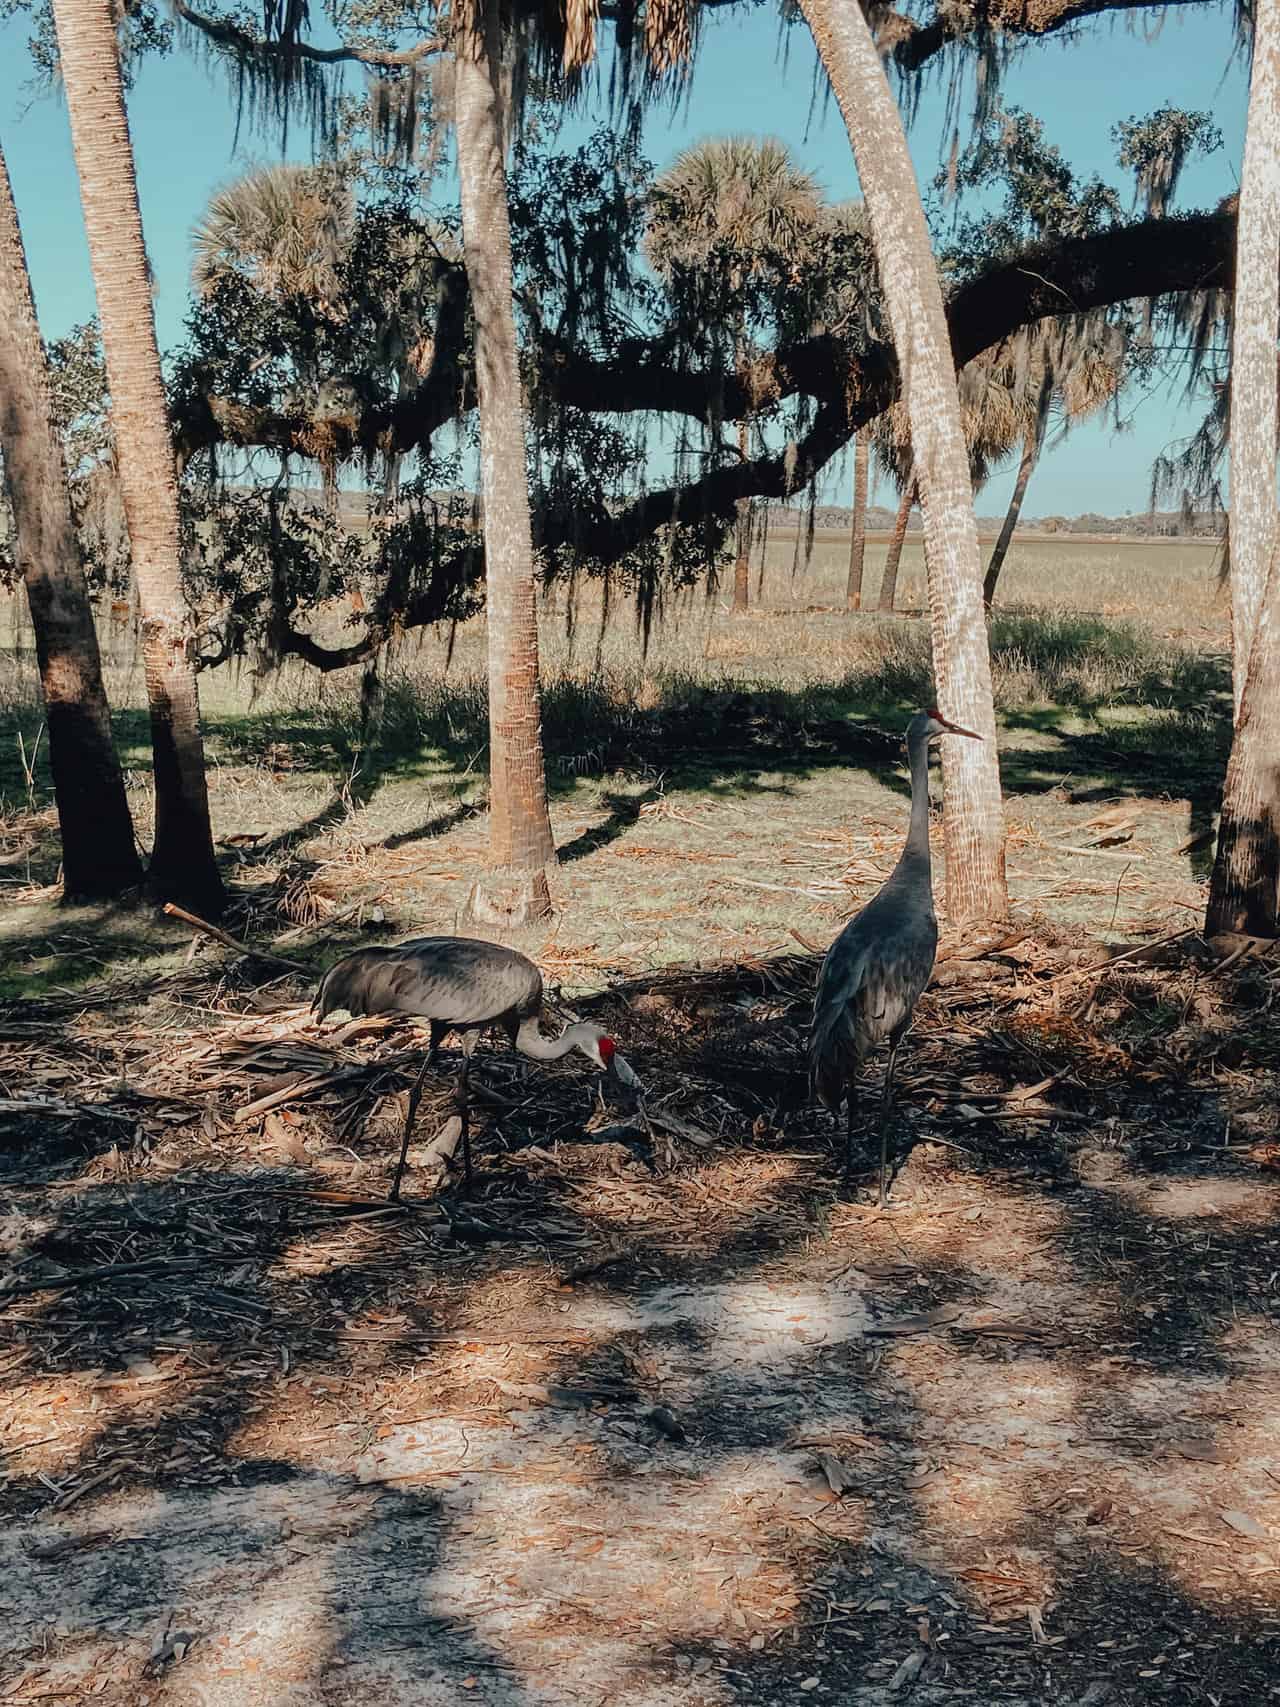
[{"xmin": 0, "ymin": 538, "xmax": 1280, "ymax": 1707}]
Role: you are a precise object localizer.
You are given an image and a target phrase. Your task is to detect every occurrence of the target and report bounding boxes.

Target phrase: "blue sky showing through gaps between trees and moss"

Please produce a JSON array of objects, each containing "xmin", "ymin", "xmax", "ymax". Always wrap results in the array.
[{"xmin": 0, "ymin": 5, "xmax": 1246, "ymax": 516}]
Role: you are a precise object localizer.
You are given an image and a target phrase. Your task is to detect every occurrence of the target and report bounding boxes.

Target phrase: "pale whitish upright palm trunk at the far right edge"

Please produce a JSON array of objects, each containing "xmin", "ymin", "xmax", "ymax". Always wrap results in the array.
[{"xmin": 1229, "ymin": 0, "xmax": 1280, "ymax": 717}]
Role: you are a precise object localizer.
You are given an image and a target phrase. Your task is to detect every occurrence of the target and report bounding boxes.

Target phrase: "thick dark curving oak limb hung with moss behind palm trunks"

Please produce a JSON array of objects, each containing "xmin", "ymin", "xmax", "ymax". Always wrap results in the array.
[{"xmin": 176, "ymin": 212, "xmax": 1236, "ymax": 535}]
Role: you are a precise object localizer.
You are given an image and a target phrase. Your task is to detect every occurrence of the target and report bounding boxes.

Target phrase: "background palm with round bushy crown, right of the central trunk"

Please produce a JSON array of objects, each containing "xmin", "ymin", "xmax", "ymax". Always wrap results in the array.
[{"xmin": 645, "ymin": 137, "xmax": 821, "ymax": 611}]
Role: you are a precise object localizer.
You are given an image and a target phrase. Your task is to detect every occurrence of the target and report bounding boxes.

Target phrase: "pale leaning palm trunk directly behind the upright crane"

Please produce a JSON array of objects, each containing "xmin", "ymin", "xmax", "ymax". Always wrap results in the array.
[{"xmin": 800, "ymin": 0, "xmax": 1009, "ymax": 925}]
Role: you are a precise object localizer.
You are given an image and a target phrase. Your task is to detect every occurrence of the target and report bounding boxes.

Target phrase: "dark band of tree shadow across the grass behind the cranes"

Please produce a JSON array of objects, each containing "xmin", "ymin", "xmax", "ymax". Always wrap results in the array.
[{"xmin": 0, "ymin": 620, "xmax": 1231, "ymax": 928}]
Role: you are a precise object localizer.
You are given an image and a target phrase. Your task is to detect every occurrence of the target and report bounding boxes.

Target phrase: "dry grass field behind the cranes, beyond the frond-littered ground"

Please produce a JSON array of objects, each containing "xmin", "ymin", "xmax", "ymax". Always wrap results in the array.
[{"xmin": 0, "ymin": 522, "xmax": 1229, "ymax": 1010}]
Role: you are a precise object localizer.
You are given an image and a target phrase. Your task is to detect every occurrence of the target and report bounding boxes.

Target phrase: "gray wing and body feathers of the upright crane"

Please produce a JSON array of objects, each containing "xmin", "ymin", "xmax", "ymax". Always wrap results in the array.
[{"xmin": 809, "ymin": 903, "xmax": 937, "ymax": 1110}]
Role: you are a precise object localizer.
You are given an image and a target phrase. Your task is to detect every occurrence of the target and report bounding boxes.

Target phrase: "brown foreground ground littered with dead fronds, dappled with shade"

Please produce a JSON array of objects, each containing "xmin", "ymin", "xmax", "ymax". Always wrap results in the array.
[{"xmin": 0, "ymin": 925, "xmax": 1280, "ymax": 1707}]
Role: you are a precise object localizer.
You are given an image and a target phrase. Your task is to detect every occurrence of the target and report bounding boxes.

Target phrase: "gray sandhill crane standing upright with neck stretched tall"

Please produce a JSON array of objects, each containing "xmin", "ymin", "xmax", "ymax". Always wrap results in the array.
[{"xmin": 809, "ymin": 710, "xmax": 981, "ymax": 1209}]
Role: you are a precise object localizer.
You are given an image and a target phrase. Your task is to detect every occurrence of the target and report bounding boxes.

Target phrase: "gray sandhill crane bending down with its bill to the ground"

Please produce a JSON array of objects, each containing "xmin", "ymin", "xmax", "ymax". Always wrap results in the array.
[{"xmin": 311, "ymin": 937, "xmax": 640, "ymax": 1203}]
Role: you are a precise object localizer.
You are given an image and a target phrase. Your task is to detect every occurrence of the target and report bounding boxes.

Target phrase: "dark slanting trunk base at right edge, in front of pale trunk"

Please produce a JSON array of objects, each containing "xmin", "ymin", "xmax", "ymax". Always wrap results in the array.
[{"xmin": 1205, "ymin": 542, "xmax": 1280, "ymax": 937}]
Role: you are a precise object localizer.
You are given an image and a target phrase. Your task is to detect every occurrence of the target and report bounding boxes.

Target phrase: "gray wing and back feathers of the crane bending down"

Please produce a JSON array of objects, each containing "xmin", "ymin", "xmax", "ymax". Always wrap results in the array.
[{"xmin": 314, "ymin": 937, "xmax": 543, "ymax": 1028}]
